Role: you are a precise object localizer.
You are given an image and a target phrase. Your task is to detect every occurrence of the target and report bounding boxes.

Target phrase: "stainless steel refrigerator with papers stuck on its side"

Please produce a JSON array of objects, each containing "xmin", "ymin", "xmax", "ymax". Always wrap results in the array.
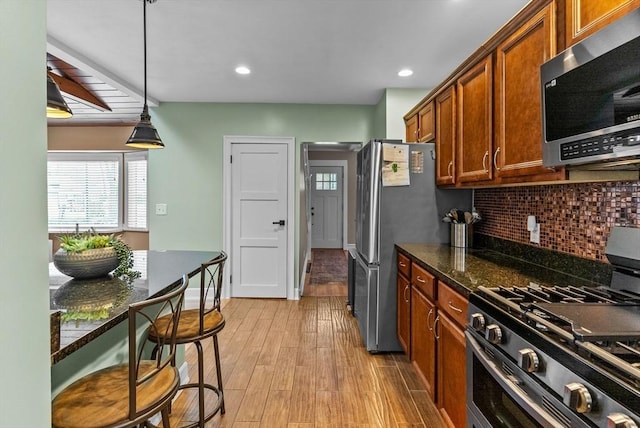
[{"xmin": 349, "ymin": 140, "xmax": 471, "ymax": 353}]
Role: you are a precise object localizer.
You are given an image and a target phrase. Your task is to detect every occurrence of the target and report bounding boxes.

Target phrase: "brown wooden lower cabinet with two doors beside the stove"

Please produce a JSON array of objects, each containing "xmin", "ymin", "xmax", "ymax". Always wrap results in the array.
[{"xmin": 398, "ymin": 254, "xmax": 468, "ymax": 428}]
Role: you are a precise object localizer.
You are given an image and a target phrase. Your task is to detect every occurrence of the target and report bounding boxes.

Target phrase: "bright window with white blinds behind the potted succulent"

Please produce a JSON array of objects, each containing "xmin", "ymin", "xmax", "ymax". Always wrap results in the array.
[{"xmin": 47, "ymin": 153, "xmax": 147, "ymax": 232}]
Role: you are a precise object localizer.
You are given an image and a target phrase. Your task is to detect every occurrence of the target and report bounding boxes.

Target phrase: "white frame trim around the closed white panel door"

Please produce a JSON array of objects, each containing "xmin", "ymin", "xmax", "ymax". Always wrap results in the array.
[{"xmin": 222, "ymin": 135, "xmax": 300, "ymax": 300}]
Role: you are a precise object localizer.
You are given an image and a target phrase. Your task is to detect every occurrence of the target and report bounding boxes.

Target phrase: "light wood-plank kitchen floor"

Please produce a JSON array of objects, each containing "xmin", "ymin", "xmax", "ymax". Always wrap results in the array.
[{"xmin": 171, "ymin": 249, "xmax": 444, "ymax": 428}]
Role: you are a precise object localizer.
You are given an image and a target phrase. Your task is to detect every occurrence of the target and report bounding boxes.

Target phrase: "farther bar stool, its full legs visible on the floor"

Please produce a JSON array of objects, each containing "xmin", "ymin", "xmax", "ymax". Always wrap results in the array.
[{"xmin": 150, "ymin": 251, "xmax": 227, "ymax": 428}]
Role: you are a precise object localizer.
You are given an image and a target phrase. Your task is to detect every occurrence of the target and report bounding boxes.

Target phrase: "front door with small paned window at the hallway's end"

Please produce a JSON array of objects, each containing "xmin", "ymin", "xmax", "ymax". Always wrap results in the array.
[{"xmin": 310, "ymin": 166, "xmax": 344, "ymax": 248}]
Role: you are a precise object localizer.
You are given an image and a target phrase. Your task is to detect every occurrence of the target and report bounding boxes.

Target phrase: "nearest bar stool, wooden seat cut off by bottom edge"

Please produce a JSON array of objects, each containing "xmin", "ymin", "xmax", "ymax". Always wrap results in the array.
[{"xmin": 51, "ymin": 275, "xmax": 189, "ymax": 428}]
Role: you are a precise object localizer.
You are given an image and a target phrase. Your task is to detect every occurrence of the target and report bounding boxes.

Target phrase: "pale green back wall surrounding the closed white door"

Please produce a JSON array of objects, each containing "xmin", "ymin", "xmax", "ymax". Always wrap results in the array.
[{"xmin": 149, "ymin": 103, "xmax": 374, "ymax": 285}]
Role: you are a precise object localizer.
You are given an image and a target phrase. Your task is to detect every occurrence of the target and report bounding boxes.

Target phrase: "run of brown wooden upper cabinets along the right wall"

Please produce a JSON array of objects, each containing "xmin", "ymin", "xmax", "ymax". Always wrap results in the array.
[{"xmin": 405, "ymin": 0, "xmax": 640, "ymax": 187}]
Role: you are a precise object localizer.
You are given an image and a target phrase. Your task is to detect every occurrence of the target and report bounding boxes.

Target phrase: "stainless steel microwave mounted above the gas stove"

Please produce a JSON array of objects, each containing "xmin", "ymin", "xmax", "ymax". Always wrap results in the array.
[{"xmin": 540, "ymin": 9, "xmax": 640, "ymax": 166}]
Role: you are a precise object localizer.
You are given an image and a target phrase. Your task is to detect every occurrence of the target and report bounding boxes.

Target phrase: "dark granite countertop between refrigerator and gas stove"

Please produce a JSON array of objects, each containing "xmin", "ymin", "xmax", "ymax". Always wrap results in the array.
[{"xmin": 396, "ymin": 243, "xmax": 602, "ymax": 295}]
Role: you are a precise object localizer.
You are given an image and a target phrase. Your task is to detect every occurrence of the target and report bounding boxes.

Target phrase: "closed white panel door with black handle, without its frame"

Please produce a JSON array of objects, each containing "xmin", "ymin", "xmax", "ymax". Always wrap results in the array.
[{"xmin": 231, "ymin": 143, "xmax": 293, "ymax": 297}]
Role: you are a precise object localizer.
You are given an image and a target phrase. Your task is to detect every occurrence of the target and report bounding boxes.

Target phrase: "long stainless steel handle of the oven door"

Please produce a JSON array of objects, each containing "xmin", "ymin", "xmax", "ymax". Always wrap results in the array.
[{"xmin": 464, "ymin": 331, "xmax": 558, "ymax": 426}]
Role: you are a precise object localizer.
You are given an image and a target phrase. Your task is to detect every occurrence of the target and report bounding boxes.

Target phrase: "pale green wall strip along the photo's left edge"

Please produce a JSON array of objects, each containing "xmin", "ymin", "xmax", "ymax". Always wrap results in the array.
[{"xmin": 0, "ymin": 0, "xmax": 51, "ymax": 428}]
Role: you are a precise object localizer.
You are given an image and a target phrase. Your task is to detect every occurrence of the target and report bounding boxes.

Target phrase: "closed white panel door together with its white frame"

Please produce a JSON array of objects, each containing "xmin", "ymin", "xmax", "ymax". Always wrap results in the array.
[{"xmin": 223, "ymin": 136, "xmax": 295, "ymax": 299}]
